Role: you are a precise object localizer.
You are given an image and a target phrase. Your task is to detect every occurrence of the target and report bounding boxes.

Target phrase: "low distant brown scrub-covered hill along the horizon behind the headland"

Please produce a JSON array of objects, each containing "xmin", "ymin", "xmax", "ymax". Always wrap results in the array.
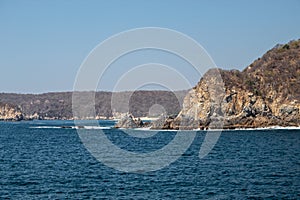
[{"xmin": 0, "ymin": 91, "xmax": 188, "ymax": 119}]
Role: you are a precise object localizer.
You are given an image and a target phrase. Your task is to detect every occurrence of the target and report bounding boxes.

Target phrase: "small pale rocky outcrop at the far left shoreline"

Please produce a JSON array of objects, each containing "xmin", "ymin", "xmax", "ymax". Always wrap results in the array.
[{"xmin": 0, "ymin": 103, "xmax": 23, "ymax": 121}]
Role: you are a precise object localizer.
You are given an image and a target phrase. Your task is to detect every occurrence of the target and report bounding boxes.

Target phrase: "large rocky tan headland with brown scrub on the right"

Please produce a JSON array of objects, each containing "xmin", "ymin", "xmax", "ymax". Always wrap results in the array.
[{"xmin": 170, "ymin": 40, "xmax": 300, "ymax": 129}]
